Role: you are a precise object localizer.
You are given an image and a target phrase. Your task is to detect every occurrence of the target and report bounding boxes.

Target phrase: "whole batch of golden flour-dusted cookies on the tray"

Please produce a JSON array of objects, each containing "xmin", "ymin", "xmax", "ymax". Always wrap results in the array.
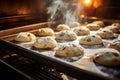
[{"xmin": 14, "ymin": 21, "xmax": 120, "ymax": 66}]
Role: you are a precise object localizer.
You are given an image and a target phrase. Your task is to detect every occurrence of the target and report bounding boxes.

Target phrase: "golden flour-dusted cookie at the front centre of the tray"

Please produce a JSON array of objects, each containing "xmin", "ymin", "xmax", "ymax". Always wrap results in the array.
[{"xmin": 55, "ymin": 44, "xmax": 84, "ymax": 57}]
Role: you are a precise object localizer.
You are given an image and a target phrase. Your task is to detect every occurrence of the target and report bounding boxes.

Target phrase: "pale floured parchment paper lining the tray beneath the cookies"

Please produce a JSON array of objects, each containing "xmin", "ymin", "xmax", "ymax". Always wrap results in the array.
[{"xmin": 12, "ymin": 31, "xmax": 120, "ymax": 79}]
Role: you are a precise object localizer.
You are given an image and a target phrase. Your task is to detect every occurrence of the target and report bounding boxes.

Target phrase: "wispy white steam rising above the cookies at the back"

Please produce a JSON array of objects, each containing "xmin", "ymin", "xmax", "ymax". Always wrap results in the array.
[{"xmin": 47, "ymin": 0, "xmax": 81, "ymax": 25}]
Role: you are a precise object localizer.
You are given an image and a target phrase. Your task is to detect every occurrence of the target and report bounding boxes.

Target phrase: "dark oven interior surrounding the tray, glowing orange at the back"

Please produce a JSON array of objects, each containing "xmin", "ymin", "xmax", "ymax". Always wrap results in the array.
[{"xmin": 0, "ymin": 0, "xmax": 120, "ymax": 80}]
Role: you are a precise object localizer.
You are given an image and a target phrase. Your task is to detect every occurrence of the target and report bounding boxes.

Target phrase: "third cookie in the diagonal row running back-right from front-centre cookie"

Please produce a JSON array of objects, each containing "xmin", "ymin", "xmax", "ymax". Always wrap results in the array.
[{"xmin": 96, "ymin": 29, "xmax": 114, "ymax": 39}]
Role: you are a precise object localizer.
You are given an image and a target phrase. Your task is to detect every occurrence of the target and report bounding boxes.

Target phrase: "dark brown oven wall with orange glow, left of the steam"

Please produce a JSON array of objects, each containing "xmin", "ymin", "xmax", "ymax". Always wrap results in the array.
[{"xmin": 0, "ymin": 0, "xmax": 49, "ymax": 30}]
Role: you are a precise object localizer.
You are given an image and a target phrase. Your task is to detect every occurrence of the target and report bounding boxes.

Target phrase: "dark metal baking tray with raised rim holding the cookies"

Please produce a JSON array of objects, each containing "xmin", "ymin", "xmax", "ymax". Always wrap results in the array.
[{"xmin": 0, "ymin": 22, "xmax": 120, "ymax": 80}]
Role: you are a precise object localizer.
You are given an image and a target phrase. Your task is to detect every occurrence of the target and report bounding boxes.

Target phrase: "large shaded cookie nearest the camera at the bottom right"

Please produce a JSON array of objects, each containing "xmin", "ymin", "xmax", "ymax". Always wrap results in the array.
[{"xmin": 94, "ymin": 48, "xmax": 120, "ymax": 66}]
